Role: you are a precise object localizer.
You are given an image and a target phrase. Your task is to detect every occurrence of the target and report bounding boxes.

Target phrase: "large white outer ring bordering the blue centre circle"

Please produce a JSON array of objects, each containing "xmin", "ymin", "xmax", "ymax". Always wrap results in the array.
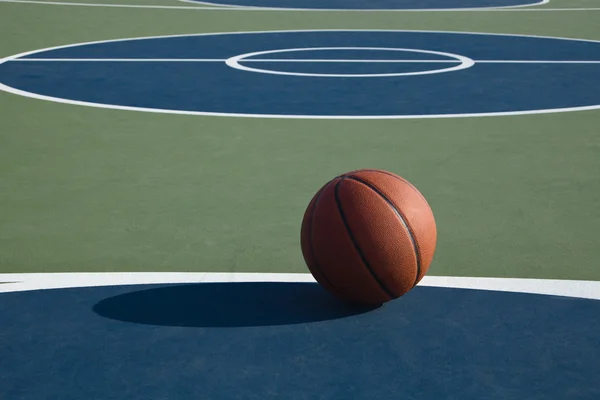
[{"xmin": 0, "ymin": 29, "xmax": 600, "ymax": 120}]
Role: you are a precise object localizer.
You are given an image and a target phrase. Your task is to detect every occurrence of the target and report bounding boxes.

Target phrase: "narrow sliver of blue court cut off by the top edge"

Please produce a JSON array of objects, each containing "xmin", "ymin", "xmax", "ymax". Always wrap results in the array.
[{"xmin": 192, "ymin": 0, "xmax": 545, "ymax": 10}]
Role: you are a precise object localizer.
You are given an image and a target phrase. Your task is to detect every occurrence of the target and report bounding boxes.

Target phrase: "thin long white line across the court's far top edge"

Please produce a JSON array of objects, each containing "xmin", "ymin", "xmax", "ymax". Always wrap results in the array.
[{"xmin": 0, "ymin": 0, "xmax": 600, "ymax": 12}]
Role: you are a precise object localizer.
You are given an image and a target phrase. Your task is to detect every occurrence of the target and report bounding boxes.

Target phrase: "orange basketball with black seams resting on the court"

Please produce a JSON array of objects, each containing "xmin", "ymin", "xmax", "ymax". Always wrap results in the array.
[{"xmin": 301, "ymin": 169, "xmax": 437, "ymax": 304}]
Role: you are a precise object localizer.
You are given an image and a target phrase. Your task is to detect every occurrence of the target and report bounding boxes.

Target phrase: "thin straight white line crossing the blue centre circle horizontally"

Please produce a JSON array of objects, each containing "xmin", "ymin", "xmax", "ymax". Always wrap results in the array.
[{"xmin": 7, "ymin": 58, "xmax": 600, "ymax": 64}]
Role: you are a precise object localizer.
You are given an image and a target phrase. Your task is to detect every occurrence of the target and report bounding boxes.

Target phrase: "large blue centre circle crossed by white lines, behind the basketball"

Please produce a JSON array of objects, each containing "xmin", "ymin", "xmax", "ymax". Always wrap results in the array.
[{"xmin": 0, "ymin": 31, "xmax": 600, "ymax": 118}]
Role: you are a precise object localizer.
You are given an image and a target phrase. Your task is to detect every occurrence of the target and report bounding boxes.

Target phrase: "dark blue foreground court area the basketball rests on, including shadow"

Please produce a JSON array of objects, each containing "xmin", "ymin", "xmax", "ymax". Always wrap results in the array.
[{"xmin": 0, "ymin": 283, "xmax": 600, "ymax": 400}]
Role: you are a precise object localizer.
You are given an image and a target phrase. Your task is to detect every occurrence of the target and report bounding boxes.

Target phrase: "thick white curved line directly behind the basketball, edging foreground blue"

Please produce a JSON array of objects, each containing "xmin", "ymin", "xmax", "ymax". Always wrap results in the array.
[{"xmin": 0, "ymin": 272, "xmax": 600, "ymax": 300}]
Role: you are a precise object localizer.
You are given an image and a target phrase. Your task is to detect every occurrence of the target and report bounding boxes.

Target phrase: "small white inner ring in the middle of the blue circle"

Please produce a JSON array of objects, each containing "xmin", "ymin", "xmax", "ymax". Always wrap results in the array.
[{"xmin": 225, "ymin": 47, "xmax": 475, "ymax": 78}]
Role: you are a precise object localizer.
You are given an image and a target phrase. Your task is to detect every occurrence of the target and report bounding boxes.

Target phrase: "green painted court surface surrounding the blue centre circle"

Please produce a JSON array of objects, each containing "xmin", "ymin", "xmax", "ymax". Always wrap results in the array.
[{"xmin": 0, "ymin": 0, "xmax": 600, "ymax": 280}]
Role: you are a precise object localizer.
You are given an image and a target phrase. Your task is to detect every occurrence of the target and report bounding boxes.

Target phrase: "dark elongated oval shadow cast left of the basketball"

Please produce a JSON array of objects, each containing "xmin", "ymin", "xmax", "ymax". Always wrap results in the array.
[{"xmin": 93, "ymin": 282, "xmax": 378, "ymax": 327}]
